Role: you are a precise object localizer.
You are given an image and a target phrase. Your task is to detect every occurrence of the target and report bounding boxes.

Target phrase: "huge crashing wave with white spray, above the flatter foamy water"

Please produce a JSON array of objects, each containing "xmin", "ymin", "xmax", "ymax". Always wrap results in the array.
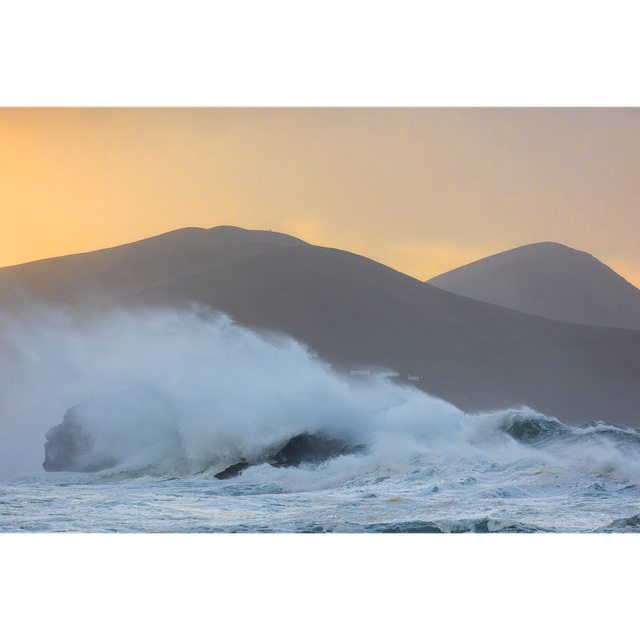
[{"xmin": 0, "ymin": 306, "xmax": 640, "ymax": 483}]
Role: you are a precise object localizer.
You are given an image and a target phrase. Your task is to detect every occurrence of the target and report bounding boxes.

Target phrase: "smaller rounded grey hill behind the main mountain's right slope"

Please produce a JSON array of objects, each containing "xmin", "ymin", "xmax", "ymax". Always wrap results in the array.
[{"xmin": 427, "ymin": 242, "xmax": 640, "ymax": 329}]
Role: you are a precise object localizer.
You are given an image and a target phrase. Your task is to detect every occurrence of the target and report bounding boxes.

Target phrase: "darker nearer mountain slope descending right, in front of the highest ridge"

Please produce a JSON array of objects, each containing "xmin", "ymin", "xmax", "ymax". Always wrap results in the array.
[{"xmin": 127, "ymin": 245, "xmax": 640, "ymax": 427}]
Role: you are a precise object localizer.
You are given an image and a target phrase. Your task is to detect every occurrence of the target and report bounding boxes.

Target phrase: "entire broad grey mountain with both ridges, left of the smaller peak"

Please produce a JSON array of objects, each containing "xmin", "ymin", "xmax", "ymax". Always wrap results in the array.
[{"xmin": 0, "ymin": 227, "xmax": 640, "ymax": 427}]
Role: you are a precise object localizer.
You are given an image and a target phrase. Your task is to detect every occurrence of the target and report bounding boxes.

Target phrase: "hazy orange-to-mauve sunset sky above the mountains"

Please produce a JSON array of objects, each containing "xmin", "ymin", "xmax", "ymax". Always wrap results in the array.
[{"xmin": 0, "ymin": 107, "xmax": 640, "ymax": 287}]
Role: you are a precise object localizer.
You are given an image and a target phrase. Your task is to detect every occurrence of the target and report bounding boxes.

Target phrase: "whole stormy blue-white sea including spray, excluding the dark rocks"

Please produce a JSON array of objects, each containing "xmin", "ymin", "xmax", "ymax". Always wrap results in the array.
[{"xmin": 0, "ymin": 307, "xmax": 640, "ymax": 534}]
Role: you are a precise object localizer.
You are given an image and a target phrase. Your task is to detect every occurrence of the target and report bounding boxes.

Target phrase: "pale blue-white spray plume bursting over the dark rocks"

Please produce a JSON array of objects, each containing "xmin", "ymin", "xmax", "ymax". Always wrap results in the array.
[{"xmin": 0, "ymin": 304, "xmax": 464, "ymax": 477}]
